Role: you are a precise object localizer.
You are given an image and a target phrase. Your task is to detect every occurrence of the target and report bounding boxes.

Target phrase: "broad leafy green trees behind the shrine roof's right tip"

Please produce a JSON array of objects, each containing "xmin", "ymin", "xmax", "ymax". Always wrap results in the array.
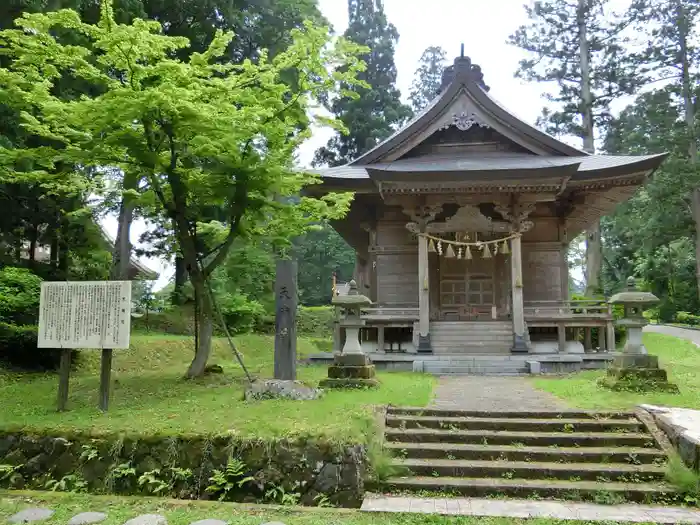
[{"xmin": 602, "ymin": 84, "xmax": 700, "ymax": 312}]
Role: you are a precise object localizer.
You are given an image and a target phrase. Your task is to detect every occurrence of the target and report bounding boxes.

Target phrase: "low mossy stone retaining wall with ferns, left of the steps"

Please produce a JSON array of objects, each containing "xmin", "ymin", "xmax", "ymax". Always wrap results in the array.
[{"xmin": 0, "ymin": 431, "xmax": 368, "ymax": 507}]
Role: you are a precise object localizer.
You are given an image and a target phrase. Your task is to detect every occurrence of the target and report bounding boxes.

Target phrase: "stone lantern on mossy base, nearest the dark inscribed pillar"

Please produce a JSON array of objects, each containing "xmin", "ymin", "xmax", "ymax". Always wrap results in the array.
[{"xmin": 319, "ymin": 281, "xmax": 379, "ymax": 388}]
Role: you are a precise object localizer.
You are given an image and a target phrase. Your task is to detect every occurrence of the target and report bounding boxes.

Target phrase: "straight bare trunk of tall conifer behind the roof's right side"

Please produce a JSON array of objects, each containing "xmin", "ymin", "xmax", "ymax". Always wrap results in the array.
[{"xmin": 577, "ymin": 0, "xmax": 603, "ymax": 297}]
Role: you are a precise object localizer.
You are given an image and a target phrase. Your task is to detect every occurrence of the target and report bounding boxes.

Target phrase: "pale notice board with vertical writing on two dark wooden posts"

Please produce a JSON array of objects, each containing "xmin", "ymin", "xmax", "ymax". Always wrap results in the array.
[{"xmin": 37, "ymin": 281, "xmax": 131, "ymax": 412}]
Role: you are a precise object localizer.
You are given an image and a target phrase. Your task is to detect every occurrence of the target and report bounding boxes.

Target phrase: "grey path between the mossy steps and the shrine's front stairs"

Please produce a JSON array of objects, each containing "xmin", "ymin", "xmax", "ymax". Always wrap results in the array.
[{"xmin": 431, "ymin": 374, "xmax": 568, "ymax": 412}]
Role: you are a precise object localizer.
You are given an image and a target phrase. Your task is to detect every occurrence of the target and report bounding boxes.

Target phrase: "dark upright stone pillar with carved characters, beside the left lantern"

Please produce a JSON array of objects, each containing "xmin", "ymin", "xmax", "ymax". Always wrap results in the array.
[{"xmin": 274, "ymin": 260, "xmax": 297, "ymax": 380}]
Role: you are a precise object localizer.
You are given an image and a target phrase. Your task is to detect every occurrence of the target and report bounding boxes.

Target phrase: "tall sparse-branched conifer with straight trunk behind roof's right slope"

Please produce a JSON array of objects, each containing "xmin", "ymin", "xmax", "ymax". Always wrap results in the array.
[{"xmin": 509, "ymin": 0, "xmax": 637, "ymax": 295}]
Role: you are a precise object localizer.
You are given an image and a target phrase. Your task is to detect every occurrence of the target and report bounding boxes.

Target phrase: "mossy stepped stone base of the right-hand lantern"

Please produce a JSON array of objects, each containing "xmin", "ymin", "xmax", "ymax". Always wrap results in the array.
[{"xmin": 601, "ymin": 354, "xmax": 678, "ymax": 394}]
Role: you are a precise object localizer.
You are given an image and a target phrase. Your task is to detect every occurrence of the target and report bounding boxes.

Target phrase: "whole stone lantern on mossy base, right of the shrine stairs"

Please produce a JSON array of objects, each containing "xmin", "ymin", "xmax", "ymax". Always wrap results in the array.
[{"xmin": 602, "ymin": 277, "xmax": 678, "ymax": 393}]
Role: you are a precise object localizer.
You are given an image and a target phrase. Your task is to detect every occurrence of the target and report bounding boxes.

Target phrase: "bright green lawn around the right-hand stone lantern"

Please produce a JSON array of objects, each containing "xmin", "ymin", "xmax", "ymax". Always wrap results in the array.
[{"xmin": 535, "ymin": 334, "xmax": 700, "ymax": 409}]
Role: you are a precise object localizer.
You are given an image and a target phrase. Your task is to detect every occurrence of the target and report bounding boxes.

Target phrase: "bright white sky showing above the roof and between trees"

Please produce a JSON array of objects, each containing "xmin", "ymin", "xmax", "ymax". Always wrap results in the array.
[{"xmin": 104, "ymin": 0, "xmax": 621, "ymax": 288}]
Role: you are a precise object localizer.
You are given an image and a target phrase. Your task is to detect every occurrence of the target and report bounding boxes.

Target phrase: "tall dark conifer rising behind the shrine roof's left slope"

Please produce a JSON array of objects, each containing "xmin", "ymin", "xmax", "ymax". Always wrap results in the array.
[{"xmin": 314, "ymin": 0, "xmax": 411, "ymax": 166}]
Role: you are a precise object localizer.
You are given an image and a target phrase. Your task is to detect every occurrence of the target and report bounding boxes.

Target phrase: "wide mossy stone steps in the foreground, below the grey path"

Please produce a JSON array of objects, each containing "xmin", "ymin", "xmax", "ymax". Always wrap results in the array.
[{"xmin": 383, "ymin": 408, "xmax": 675, "ymax": 503}]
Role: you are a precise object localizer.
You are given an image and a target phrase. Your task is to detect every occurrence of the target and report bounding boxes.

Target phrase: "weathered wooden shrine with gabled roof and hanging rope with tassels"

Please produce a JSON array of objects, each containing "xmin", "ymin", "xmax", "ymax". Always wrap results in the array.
[{"xmin": 308, "ymin": 56, "xmax": 664, "ymax": 370}]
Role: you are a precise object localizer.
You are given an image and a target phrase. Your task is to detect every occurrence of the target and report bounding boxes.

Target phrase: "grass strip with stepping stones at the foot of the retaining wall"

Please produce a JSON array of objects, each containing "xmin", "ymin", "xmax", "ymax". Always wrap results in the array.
[{"xmin": 0, "ymin": 490, "xmax": 596, "ymax": 525}]
